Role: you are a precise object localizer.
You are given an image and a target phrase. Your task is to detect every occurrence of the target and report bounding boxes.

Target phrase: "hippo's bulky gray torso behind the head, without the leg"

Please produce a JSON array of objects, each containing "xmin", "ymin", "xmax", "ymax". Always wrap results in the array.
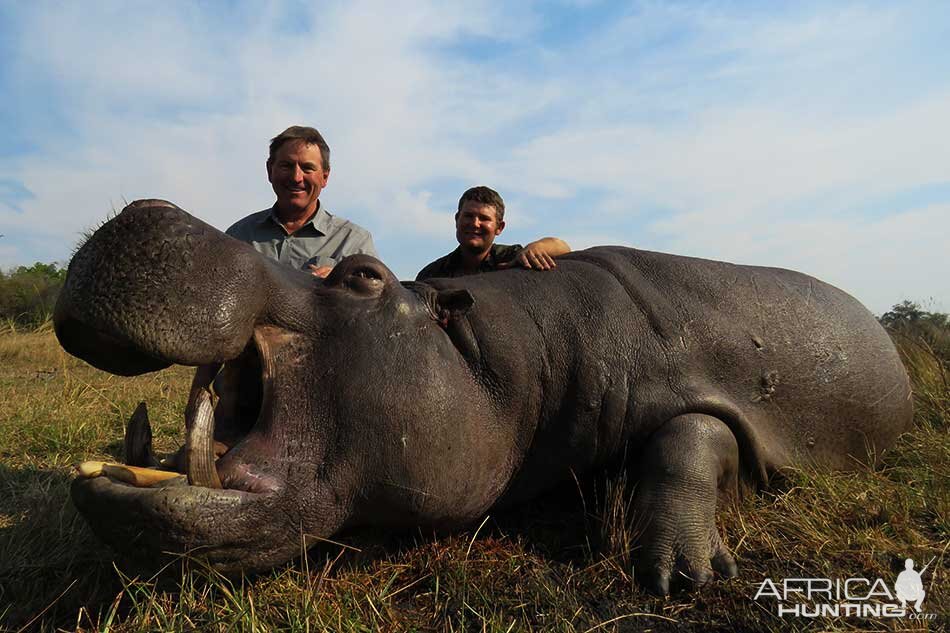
[{"xmin": 424, "ymin": 247, "xmax": 911, "ymax": 499}]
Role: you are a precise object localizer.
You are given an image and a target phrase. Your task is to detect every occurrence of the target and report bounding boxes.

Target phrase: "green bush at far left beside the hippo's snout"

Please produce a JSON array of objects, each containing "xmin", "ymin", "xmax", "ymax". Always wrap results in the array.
[{"xmin": 0, "ymin": 262, "xmax": 66, "ymax": 329}]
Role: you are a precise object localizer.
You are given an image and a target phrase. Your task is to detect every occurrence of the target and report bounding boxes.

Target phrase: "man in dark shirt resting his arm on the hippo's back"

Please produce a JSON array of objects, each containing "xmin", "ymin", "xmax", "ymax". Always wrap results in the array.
[{"xmin": 416, "ymin": 187, "xmax": 571, "ymax": 281}]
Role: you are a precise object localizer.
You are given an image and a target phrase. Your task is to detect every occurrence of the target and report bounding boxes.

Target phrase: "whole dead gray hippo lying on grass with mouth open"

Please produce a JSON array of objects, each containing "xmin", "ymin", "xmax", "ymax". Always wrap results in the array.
[{"xmin": 54, "ymin": 200, "xmax": 912, "ymax": 594}]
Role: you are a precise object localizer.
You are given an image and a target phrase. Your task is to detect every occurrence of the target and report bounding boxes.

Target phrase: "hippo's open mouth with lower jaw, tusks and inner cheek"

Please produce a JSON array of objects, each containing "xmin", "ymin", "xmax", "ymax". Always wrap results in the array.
[{"xmin": 72, "ymin": 326, "xmax": 308, "ymax": 572}]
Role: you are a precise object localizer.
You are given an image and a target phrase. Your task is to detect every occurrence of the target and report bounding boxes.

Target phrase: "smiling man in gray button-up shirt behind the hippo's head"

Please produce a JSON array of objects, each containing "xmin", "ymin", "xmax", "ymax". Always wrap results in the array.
[{"xmin": 226, "ymin": 125, "xmax": 379, "ymax": 277}]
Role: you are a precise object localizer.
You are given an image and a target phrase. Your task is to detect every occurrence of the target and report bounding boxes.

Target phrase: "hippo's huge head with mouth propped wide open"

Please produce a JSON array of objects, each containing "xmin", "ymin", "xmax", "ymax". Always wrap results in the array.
[{"xmin": 54, "ymin": 200, "xmax": 506, "ymax": 572}]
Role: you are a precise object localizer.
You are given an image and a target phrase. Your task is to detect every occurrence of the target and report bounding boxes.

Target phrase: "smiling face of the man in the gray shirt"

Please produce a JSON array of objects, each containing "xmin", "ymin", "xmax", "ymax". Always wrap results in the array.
[{"xmin": 267, "ymin": 141, "xmax": 330, "ymax": 216}]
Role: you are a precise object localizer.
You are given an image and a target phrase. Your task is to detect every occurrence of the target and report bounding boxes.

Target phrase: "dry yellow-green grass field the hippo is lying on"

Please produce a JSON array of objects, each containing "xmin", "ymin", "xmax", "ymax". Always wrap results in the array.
[{"xmin": 0, "ymin": 326, "xmax": 950, "ymax": 631}]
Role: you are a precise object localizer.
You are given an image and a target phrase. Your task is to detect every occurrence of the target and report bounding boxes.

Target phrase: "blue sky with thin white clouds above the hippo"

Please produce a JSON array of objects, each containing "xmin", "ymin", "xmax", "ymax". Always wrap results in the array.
[{"xmin": 0, "ymin": 0, "xmax": 950, "ymax": 313}]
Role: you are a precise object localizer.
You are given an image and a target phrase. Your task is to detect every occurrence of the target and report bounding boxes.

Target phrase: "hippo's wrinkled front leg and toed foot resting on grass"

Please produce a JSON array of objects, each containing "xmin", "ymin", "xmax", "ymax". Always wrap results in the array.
[{"xmin": 634, "ymin": 414, "xmax": 739, "ymax": 595}]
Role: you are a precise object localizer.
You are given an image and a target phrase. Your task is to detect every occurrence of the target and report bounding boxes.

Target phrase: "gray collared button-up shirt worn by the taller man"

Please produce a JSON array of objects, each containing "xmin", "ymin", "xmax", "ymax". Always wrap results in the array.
[{"xmin": 226, "ymin": 206, "xmax": 379, "ymax": 272}]
